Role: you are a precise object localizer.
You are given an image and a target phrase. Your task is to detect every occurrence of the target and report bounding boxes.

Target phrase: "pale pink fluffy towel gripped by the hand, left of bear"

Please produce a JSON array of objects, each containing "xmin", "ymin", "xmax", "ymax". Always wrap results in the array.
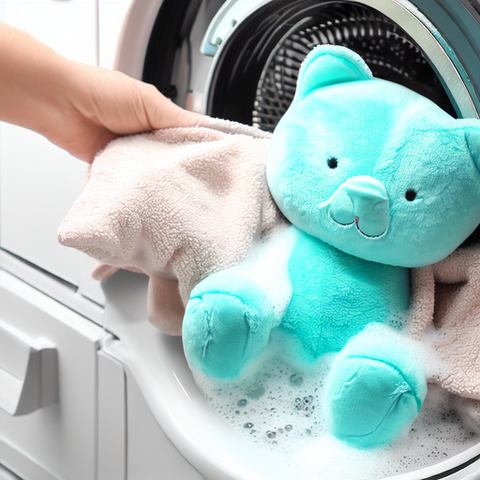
[{"xmin": 58, "ymin": 117, "xmax": 284, "ymax": 335}]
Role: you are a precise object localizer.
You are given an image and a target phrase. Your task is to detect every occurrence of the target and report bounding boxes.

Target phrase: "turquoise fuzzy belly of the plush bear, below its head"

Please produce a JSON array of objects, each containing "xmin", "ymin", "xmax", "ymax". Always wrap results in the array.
[{"xmin": 279, "ymin": 233, "xmax": 410, "ymax": 361}]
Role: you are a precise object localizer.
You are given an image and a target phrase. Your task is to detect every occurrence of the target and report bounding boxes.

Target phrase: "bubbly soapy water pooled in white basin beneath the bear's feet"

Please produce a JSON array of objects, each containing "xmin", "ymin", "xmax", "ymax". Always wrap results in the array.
[{"xmin": 194, "ymin": 344, "xmax": 480, "ymax": 480}]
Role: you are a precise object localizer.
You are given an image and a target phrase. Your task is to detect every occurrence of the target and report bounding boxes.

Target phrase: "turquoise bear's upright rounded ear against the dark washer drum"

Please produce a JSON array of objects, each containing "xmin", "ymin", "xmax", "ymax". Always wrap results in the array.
[{"xmin": 295, "ymin": 45, "xmax": 373, "ymax": 99}]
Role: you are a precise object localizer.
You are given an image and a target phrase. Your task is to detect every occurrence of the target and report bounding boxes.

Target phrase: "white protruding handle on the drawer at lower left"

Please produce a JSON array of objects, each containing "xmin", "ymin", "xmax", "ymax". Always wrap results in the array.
[{"xmin": 0, "ymin": 320, "xmax": 58, "ymax": 416}]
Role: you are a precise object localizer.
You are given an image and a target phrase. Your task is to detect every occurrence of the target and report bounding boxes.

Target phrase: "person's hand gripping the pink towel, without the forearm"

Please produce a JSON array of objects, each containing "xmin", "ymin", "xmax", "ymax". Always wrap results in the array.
[{"xmin": 50, "ymin": 63, "xmax": 202, "ymax": 162}]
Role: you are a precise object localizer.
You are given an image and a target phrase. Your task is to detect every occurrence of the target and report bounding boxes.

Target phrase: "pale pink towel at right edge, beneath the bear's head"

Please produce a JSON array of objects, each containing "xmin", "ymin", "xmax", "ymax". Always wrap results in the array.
[{"xmin": 409, "ymin": 245, "xmax": 480, "ymax": 400}]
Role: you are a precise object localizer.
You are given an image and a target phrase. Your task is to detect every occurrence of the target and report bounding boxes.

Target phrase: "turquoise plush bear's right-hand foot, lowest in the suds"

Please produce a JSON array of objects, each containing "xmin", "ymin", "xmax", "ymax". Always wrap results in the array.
[{"xmin": 326, "ymin": 334, "xmax": 427, "ymax": 448}]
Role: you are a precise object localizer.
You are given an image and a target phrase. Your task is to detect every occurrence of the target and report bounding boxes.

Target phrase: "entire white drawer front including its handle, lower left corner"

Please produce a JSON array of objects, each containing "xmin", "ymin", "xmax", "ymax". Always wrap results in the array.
[{"xmin": 0, "ymin": 269, "xmax": 110, "ymax": 480}]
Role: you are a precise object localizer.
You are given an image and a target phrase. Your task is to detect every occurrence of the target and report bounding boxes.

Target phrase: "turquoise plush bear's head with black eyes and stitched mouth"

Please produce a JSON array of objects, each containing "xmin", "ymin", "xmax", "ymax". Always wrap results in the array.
[{"xmin": 267, "ymin": 46, "xmax": 480, "ymax": 267}]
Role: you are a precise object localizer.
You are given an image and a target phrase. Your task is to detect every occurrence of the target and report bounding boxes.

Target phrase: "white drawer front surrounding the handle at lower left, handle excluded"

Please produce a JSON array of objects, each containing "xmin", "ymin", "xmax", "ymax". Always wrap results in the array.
[{"xmin": 0, "ymin": 269, "xmax": 111, "ymax": 480}]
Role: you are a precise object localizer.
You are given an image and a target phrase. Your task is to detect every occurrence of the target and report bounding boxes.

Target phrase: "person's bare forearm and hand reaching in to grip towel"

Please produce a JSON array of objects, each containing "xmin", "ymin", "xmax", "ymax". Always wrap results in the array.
[{"xmin": 0, "ymin": 22, "xmax": 203, "ymax": 162}]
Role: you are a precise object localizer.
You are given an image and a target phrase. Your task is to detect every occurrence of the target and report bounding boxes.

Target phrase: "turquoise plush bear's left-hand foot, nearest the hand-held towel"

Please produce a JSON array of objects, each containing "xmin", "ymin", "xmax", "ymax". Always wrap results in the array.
[{"xmin": 182, "ymin": 272, "xmax": 275, "ymax": 379}]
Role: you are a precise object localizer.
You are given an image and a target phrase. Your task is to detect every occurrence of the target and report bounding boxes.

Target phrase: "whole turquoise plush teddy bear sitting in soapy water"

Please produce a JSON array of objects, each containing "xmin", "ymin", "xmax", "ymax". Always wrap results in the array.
[{"xmin": 183, "ymin": 46, "xmax": 480, "ymax": 448}]
